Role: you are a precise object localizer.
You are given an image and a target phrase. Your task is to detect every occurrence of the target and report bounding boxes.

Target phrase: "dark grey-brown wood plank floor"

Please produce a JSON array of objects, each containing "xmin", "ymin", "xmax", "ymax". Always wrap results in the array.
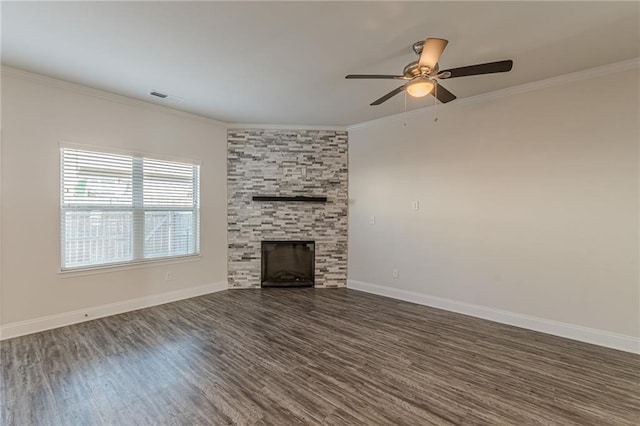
[{"xmin": 0, "ymin": 289, "xmax": 640, "ymax": 426}]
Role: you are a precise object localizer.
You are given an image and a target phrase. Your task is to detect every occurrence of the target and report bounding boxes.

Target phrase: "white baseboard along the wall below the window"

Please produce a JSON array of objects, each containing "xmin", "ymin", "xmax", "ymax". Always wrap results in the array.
[{"xmin": 0, "ymin": 281, "xmax": 228, "ymax": 340}]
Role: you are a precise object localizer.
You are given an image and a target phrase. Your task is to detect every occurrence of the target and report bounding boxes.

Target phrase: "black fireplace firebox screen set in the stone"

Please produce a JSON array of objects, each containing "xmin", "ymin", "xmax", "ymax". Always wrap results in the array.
[{"xmin": 261, "ymin": 241, "xmax": 315, "ymax": 287}]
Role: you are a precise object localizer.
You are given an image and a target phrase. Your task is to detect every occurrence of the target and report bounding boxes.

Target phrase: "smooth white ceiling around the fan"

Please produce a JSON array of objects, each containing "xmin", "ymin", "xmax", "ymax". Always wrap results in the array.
[{"xmin": 1, "ymin": 1, "xmax": 640, "ymax": 126}]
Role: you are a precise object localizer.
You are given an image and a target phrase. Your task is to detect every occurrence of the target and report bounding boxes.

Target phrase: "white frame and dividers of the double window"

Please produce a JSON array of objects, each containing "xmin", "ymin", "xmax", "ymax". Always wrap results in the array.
[{"xmin": 58, "ymin": 142, "xmax": 202, "ymax": 275}]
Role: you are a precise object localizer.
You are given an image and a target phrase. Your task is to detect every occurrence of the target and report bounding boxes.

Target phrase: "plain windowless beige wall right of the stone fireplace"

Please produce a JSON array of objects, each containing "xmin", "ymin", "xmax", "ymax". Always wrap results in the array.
[{"xmin": 349, "ymin": 67, "xmax": 640, "ymax": 342}]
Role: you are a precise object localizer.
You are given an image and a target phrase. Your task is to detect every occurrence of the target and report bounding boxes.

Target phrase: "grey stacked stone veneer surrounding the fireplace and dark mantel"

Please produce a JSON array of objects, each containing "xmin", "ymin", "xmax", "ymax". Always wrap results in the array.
[{"xmin": 227, "ymin": 129, "xmax": 348, "ymax": 288}]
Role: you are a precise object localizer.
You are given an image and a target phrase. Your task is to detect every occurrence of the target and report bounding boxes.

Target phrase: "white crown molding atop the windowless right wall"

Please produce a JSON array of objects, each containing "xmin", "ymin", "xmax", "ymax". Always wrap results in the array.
[{"xmin": 347, "ymin": 57, "xmax": 640, "ymax": 131}]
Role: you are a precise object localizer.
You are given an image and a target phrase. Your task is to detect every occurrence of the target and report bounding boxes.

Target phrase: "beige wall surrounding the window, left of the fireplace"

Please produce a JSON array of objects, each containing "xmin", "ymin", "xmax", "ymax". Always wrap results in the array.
[{"xmin": 1, "ymin": 71, "xmax": 226, "ymax": 334}]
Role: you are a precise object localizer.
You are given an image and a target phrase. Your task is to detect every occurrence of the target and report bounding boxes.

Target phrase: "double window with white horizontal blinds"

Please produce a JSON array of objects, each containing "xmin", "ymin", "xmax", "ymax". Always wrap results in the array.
[{"xmin": 60, "ymin": 148, "xmax": 200, "ymax": 270}]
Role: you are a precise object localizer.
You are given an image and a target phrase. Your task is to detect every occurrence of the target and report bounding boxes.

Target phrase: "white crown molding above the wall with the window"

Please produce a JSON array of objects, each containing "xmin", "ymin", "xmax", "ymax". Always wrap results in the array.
[{"xmin": 0, "ymin": 65, "xmax": 227, "ymax": 129}]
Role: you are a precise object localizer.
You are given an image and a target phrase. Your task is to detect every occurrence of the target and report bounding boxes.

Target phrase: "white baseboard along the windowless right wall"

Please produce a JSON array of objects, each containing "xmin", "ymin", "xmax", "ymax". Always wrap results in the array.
[{"xmin": 347, "ymin": 280, "xmax": 640, "ymax": 354}]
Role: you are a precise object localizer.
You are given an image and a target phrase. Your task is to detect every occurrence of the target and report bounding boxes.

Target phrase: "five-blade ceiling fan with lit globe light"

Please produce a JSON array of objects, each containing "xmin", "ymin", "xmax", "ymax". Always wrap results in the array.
[{"xmin": 345, "ymin": 38, "xmax": 513, "ymax": 105}]
